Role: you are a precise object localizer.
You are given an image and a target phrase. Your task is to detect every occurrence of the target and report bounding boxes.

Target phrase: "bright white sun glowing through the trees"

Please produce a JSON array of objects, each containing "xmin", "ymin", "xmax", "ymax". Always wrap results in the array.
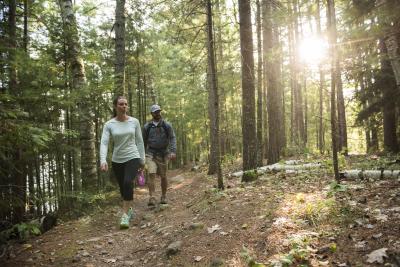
[{"xmin": 299, "ymin": 37, "xmax": 328, "ymax": 65}]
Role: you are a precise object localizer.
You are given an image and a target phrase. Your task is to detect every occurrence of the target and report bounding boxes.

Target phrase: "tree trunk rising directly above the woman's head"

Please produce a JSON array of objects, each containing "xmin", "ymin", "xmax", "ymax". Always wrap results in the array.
[{"xmin": 114, "ymin": 0, "xmax": 125, "ymax": 96}]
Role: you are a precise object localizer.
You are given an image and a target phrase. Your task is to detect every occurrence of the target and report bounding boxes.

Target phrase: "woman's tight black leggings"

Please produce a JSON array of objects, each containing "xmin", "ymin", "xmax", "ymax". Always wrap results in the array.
[{"xmin": 112, "ymin": 159, "xmax": 140, "ymax": 201}]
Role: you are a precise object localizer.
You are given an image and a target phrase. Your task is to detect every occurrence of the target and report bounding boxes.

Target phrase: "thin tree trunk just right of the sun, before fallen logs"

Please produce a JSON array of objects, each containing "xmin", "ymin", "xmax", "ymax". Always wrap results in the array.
[{"xmin": 327, "ymin": 0, "xmax": 339, "ymax": 181}]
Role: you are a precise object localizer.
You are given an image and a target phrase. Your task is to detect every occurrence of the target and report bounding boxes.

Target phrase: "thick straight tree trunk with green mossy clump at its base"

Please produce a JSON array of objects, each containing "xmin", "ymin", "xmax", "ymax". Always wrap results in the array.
[{"xmin": 239, "ymin": 0, "xmax": 257, "ymax": 181}]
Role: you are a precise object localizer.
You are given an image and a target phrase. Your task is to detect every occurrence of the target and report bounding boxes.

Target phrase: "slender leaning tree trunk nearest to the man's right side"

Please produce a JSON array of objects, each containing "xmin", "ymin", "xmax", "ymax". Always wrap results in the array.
[{"xmin": 206, "ymin": 0, "xmax": 224, "ymax": 189}]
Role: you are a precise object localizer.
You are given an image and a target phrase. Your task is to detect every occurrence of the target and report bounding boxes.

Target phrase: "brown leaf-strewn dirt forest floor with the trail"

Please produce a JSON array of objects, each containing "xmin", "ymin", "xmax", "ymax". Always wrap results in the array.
[{"xmin": 0, "ymin": 156, "xmax": 400, "ymax": 267}]
